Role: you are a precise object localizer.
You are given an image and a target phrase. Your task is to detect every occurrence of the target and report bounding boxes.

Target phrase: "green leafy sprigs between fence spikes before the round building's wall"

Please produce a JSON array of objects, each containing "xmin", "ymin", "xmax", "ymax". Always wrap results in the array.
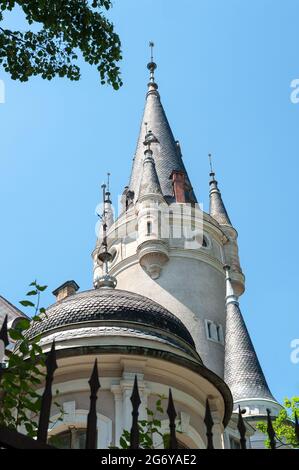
[{"xmin": 119, "ymin": 395, "xmax": 179, "ymax": 449}]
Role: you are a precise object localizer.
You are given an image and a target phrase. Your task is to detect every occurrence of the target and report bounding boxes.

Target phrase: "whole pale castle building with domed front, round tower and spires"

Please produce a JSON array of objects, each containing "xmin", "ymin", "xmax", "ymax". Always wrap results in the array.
[{"xmin": 22, "ymin": 46, "xmax": 279, "ymax": 448}]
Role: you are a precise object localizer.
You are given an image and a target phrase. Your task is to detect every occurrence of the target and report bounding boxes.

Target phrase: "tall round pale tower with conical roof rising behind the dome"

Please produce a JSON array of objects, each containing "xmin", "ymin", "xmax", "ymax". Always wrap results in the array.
[{"xmin": 93, "ymin": 53, "xmax": 244, "ymax": 378}]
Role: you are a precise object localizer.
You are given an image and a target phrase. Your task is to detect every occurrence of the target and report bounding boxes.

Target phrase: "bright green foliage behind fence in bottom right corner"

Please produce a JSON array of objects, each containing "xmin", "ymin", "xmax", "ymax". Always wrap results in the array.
[{"xmin": 256, "ymin": 397, "xmax": 299, "ymax": 448}]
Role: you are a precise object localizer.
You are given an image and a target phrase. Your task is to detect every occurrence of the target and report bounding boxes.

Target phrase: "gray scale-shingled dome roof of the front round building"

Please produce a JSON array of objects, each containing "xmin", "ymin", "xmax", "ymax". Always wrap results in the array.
[{"xmin": 28, "ymin": 288, "xmax": 195, "ymax": 348}]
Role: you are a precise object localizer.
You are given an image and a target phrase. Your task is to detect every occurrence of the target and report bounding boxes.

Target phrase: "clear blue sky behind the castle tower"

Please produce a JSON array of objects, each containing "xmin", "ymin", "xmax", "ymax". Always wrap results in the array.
[{"xmin": 0, "ymin": 0, "xmax": 299, "ymax": 400}]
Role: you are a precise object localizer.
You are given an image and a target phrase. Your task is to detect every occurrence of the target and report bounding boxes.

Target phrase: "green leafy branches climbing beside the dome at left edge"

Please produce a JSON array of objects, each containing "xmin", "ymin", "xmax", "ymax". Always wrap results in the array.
[{"xmin": 0, "ymin": 282, "xmax": 62, "ymax": 437}]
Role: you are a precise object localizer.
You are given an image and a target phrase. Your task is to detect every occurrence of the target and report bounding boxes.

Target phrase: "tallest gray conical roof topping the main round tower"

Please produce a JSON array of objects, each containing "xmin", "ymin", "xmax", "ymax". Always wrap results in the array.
[{"xmin": 128, "ymin": 44, "xmax": 196, "ymax": 202}]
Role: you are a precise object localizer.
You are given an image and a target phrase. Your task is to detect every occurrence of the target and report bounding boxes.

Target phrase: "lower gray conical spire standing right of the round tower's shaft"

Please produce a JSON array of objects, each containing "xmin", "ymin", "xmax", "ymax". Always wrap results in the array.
[{"xmin": 224, "ymin": 266, "xmax": 276, "ymax": 401}]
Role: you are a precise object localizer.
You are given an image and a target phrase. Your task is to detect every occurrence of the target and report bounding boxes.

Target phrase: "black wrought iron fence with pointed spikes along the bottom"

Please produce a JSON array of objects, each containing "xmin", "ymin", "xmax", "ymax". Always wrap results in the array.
[{"xmin": 0, "ymin": 319, "xmax": 299, "ymax": 449}]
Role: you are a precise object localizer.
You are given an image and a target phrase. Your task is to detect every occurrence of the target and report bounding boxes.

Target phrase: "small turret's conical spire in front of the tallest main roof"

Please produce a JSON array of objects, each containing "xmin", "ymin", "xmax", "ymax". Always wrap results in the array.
[{"xmin": 138, "ymin": 127, "xmax": 163, "ymax": 200}]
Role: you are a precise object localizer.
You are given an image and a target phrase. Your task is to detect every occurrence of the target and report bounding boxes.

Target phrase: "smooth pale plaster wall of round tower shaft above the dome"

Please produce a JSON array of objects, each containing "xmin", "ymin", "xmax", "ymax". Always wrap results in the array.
[{"xmin": 117, "ymin": 255, "xmax": 225, "ymax": 377}]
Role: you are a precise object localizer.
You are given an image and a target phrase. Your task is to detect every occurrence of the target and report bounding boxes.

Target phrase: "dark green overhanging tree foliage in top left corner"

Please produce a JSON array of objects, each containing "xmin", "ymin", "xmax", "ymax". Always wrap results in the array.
[{"xmin": 0, "ymin": 0, "xmax": 122, "ymax": 90}]
